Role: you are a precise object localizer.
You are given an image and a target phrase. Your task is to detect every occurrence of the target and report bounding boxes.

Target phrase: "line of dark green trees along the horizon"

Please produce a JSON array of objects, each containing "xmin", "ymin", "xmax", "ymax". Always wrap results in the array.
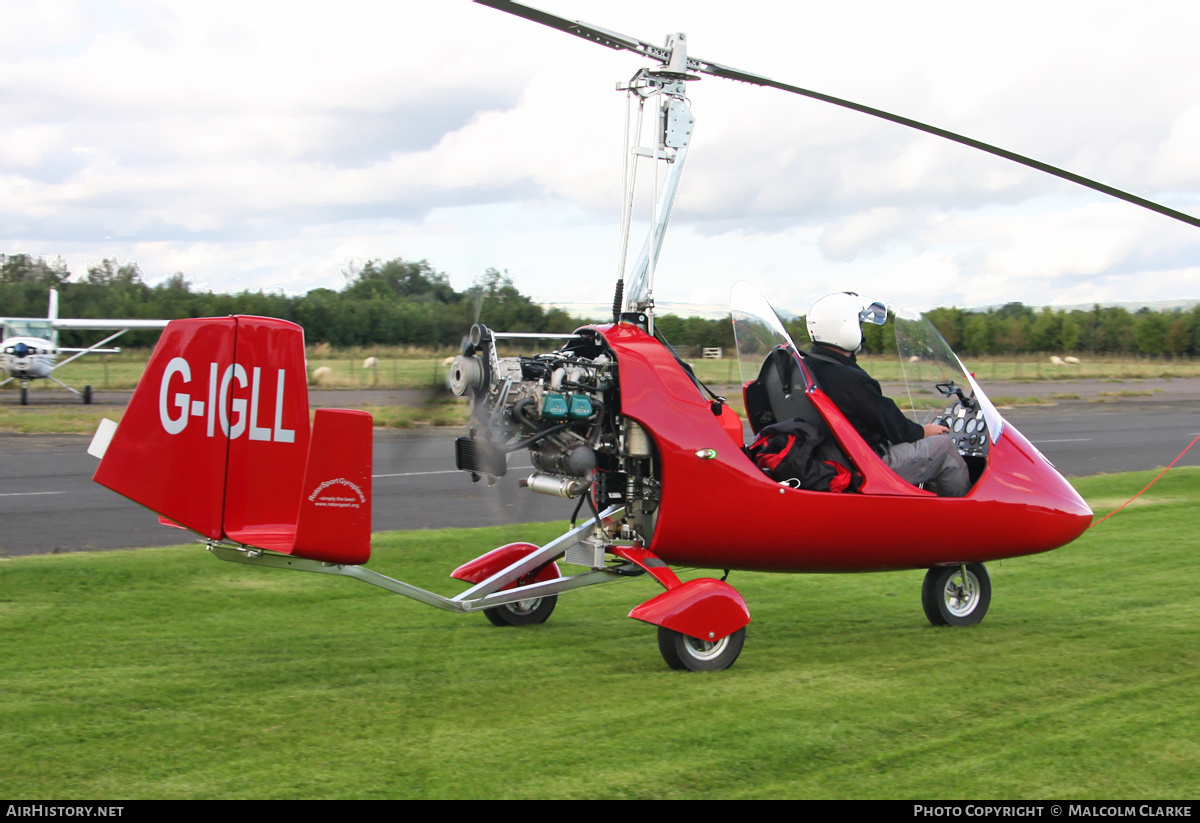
[{"xmin": 0, "ymin": 254, "xmax": 1200, "ymax": 356}]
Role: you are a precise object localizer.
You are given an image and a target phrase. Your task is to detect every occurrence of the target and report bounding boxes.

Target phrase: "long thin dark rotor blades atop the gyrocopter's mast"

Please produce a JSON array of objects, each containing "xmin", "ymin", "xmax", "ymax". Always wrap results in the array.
[{"xmin": 475, "ymin": 0, "xmax": 1200, "ymax": 227}]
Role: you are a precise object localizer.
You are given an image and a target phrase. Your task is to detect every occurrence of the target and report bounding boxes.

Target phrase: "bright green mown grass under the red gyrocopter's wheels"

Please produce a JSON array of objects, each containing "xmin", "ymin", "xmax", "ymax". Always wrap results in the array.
[{"xmin": 0, "ymin": 469, "xmax": 1200, "ymax": 800}]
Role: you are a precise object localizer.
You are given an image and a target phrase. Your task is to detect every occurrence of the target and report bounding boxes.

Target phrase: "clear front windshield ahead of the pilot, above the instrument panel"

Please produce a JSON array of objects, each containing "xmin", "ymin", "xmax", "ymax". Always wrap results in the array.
[{"xmin": 895, "ymin": 306, "xmax": 1004, "ymax": 443}]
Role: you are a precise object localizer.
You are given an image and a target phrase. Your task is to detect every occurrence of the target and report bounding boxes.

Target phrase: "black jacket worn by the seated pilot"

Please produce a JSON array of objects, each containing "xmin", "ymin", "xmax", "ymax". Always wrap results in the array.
[{"xmin": 804, "ymin": 344, "xmax": 925, "ymax": 455}]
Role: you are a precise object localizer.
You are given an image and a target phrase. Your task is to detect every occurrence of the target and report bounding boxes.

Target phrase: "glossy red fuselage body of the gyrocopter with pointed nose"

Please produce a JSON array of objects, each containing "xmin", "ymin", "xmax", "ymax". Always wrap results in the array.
[{"xmin": 596, "ymin": 324, "xmax": 1092, "ymax": 572}]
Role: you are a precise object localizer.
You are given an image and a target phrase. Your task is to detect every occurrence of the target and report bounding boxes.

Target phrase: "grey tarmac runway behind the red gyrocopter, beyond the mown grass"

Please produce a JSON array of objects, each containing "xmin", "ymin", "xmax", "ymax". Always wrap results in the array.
[{"xmin": 0, "ymin": 379, "xmax": 1200, "ymax": 555}]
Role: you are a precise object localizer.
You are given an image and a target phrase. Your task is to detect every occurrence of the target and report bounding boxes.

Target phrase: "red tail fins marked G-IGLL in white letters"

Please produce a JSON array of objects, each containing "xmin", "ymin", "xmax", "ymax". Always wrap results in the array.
[{"xmin": 92, "ymin": 316, "xmax": 372, "ymax": 565}]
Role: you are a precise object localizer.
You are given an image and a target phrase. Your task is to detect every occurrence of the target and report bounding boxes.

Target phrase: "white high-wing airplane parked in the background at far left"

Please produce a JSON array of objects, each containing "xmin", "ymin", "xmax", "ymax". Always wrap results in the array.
[{"xmin": 0, "ymin": 288, "xmax": 168, "ymax": 406}]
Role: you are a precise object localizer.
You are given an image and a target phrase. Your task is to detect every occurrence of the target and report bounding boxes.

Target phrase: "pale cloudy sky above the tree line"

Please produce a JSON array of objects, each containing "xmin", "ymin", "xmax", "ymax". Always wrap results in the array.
[{"xmin": 0, "ymin": 0, "xmax": 1200, "ymax": 312}]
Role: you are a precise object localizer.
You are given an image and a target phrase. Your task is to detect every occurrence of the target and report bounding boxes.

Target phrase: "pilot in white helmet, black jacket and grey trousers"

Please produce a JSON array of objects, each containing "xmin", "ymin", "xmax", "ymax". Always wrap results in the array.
[{"xmin": 805, "ymin": 292, "xmax": 971, "ymax": 497}]
